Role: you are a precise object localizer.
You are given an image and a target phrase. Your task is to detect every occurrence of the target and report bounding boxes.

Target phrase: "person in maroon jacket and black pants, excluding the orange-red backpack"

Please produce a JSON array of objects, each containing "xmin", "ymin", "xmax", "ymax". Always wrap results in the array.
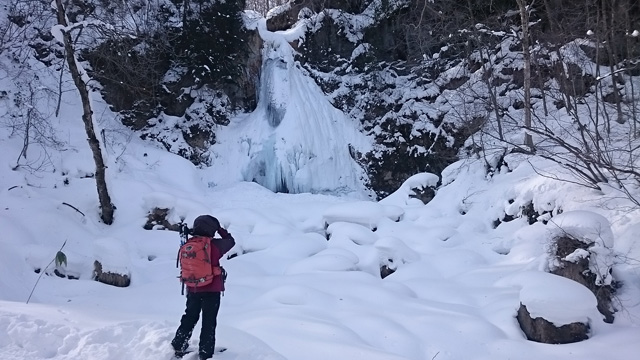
[{"xmin": 171, "ymin": 215, "xmax": 235, "ymax": 360}]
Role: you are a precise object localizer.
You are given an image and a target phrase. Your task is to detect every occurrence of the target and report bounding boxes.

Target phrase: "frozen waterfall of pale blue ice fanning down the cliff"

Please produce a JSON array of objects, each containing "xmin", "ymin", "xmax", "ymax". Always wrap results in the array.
[{"xmin": 243, "ymin": 29, "xmax": 371, "ymax": 196}]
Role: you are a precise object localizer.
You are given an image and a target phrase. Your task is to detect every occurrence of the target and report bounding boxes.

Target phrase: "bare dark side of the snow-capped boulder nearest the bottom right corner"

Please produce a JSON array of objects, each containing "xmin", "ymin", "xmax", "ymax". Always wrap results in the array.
[{"xmin": 516, "ymin": 303, "xmax": 589, "ymax": 344}]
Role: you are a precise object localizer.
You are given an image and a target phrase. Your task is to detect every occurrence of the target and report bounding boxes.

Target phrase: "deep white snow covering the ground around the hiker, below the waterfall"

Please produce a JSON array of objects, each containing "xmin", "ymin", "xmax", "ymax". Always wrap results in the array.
[{"xmin": 0, "ymin": 138, "xmax": 640, "ymax": 360}]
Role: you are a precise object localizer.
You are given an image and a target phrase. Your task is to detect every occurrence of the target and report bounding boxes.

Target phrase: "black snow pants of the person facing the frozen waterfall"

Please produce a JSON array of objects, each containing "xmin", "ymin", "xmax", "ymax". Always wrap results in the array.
[{"xmin": 171, "ymin": 292, "xmax": 220, "ymax": 359}]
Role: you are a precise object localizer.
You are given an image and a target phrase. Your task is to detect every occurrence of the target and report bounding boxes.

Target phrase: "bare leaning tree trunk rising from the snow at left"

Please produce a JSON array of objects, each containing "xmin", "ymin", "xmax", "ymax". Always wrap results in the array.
[{"xmin": 56, "ymin": 0, "xmax": 114, "ymax": 225}]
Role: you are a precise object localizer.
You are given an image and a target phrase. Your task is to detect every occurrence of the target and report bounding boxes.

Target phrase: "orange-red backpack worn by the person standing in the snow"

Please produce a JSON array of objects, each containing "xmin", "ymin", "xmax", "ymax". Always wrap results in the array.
[{"xmin": 178, "ymin": 236, "xmax": 222, "ymax": 287}]
